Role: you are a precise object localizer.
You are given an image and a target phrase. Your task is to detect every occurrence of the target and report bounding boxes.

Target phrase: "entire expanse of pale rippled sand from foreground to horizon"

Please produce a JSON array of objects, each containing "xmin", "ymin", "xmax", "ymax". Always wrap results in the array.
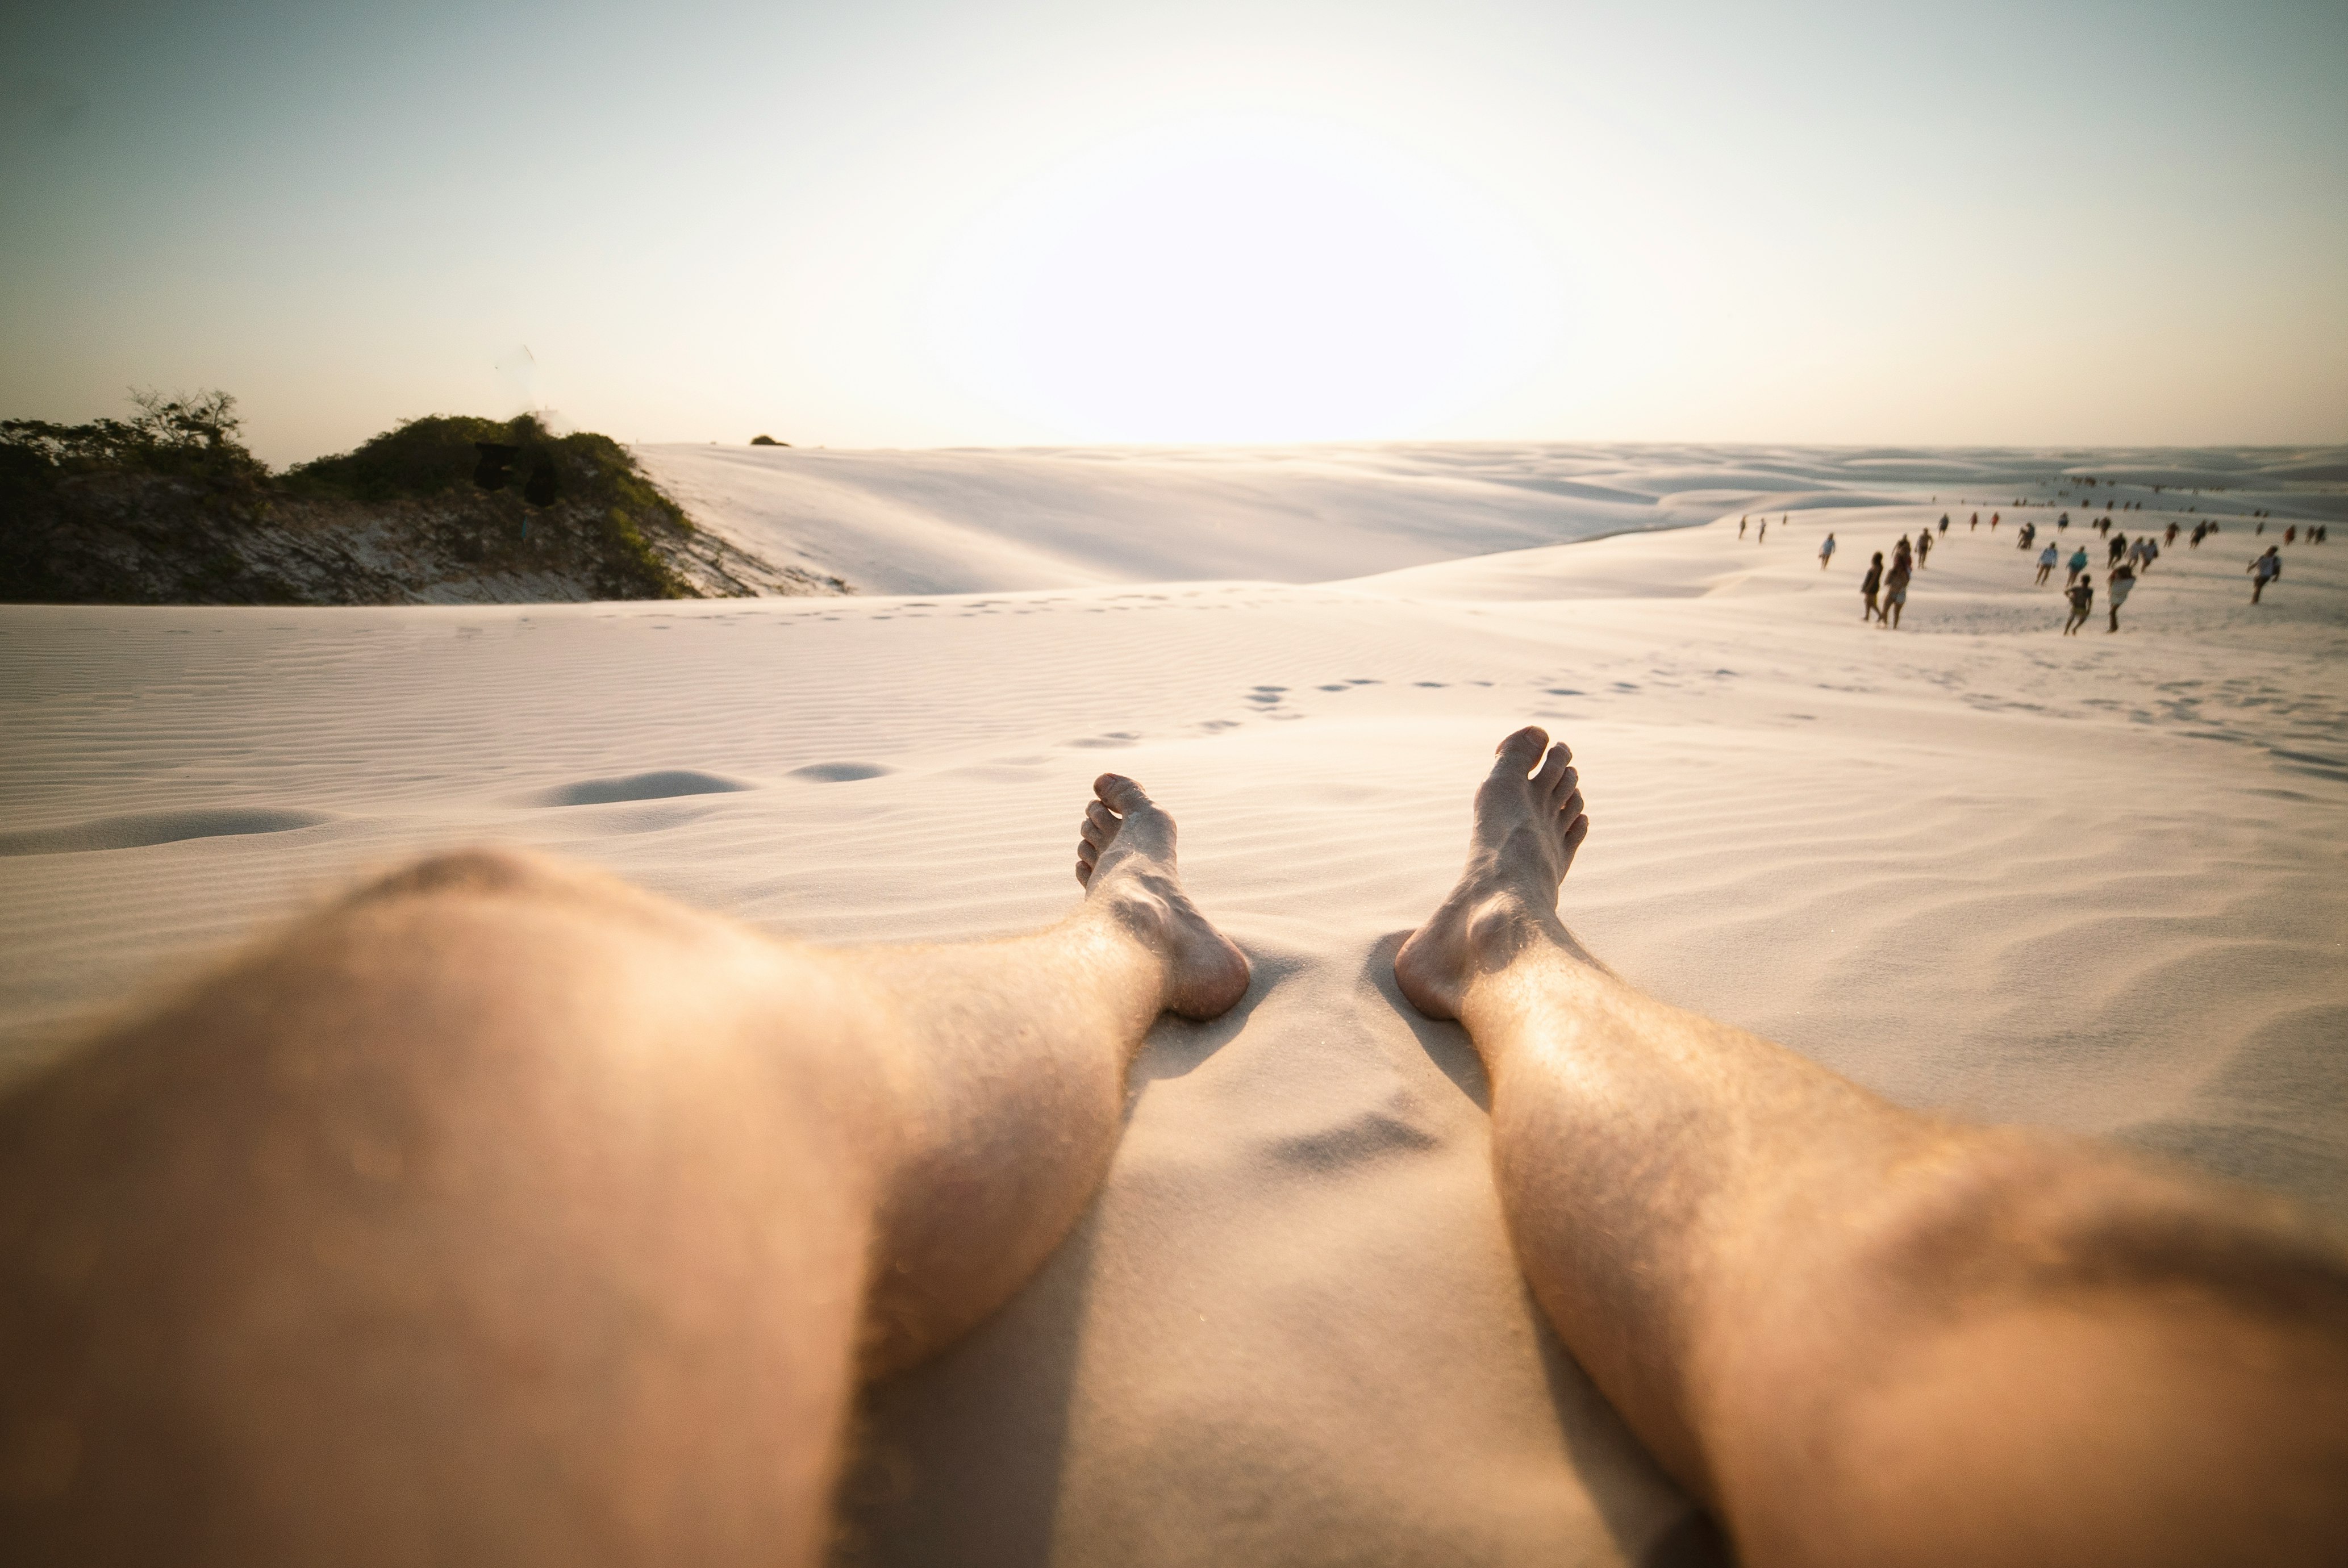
[{"xmin": 0, "ymin": 446, "xmax": 2348, "ymax": 1563}]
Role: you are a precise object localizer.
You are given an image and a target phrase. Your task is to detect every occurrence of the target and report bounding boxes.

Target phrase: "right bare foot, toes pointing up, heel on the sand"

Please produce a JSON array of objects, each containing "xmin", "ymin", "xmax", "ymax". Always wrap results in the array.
[{"xmin": 1395, "ymin": 728, "xmax": 1590, "ymax": 1019}]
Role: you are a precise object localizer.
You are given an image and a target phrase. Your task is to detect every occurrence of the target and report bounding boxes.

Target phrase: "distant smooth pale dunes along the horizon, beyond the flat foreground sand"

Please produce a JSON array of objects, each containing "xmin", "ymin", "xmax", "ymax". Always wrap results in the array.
[{"xmin": 636, "ymin": 444, "xmax": 2341, "ymax": 594}]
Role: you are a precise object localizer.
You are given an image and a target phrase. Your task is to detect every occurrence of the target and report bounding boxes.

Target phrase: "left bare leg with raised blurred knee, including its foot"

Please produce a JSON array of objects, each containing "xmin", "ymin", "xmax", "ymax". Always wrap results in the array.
[{"xmin": 0, "ymin": 777, "xmax": 1247, "ymax": 1563}]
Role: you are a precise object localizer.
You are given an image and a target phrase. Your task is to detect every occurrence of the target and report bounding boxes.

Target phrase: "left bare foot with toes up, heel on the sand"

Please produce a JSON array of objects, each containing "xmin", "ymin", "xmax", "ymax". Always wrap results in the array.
[{"xmin": 1075, "ymin": 772, "xmax": 1247, "ymax": 1019}]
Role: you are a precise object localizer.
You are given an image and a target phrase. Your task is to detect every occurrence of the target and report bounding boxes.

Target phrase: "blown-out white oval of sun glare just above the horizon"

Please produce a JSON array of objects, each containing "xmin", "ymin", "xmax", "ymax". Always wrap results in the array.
[{"xmin": 930, "ymin": 120, "xmax": 1557, "ymax": 441}]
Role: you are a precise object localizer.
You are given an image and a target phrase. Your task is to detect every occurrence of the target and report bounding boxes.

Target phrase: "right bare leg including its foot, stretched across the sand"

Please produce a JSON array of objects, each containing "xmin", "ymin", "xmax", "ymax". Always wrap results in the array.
[{"xmin": 1395, "ymin": 730, "xmax": 2348, "ymax": 1566}]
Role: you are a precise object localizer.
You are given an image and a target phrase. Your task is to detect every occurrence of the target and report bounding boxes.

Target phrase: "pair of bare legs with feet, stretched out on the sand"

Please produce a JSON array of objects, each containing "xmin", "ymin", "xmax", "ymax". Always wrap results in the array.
[{"xmin": 0, "ymin": 730, "xmax": 2348, "ymax": 1563}]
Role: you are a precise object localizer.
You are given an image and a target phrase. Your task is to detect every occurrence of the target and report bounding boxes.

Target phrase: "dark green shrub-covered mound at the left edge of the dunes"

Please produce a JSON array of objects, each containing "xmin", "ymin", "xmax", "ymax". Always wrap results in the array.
[{"xmin": 0, "ymin": 392, "xmax": 826, "ymax": 603}]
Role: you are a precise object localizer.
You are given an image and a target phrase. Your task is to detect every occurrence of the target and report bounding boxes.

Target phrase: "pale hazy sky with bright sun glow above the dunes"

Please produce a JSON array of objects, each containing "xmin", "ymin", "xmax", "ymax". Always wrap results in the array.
[{"xmin": 0, "ymin": 0, "xmax": 2348, "ymax": 462}]
